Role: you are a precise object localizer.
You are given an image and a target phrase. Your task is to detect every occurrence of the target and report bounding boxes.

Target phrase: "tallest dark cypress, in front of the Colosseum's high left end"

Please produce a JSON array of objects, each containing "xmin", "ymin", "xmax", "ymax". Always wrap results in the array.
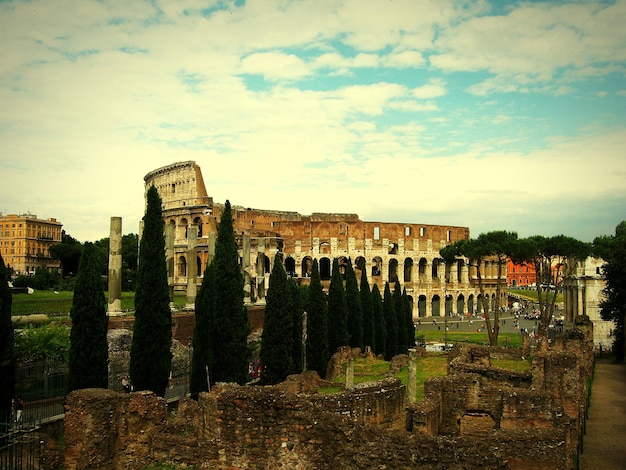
[{"xmin": 129, "ymin": 186, "xmax": 172, "ymax": 397}]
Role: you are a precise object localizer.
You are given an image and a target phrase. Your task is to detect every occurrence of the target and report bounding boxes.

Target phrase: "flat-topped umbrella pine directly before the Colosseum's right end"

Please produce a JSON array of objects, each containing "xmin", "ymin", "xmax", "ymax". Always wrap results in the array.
[{"xmin": 439, "ymin": 230, "xmax": 518, "ymax": 346}]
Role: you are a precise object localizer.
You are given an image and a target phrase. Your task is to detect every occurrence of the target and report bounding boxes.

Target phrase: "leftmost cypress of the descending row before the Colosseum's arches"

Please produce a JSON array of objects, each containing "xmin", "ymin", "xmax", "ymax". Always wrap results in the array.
[{"xmin": 261, "ymin": 253, "xmax": 295, "ymax": 385}]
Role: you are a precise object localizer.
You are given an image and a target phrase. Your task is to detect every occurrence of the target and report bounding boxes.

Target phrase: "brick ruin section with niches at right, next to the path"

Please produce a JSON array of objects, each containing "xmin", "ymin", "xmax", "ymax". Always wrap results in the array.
[{"xmin": 408, "ymin": 318, "xmax": 593, "ymax": 469}]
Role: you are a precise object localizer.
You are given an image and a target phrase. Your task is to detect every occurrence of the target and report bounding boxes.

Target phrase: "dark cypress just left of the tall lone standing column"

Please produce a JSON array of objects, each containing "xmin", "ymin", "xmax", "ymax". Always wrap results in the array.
[{"xmin": 67, "ymin": 242, "xmax": 109, "ymax": 392}]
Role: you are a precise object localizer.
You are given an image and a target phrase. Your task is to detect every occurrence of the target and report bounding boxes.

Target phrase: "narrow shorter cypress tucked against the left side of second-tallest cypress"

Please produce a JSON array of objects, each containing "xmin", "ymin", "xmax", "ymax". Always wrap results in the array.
[{"xmin": 189, "ymin": 263, "xmax": 215, "ymax": 400}]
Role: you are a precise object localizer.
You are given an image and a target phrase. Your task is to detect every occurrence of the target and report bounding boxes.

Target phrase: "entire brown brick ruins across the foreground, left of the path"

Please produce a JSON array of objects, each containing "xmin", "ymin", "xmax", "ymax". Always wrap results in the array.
[{"xmin": 56, "ymin": 318, "xmax": 593, "ymax": 470}]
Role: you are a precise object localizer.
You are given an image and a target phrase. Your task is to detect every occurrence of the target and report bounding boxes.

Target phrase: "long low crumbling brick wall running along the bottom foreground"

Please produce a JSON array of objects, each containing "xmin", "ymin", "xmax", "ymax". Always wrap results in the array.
[{"xmin": 64, "ymin": 383, "xmax": 508, "ymax": 470}]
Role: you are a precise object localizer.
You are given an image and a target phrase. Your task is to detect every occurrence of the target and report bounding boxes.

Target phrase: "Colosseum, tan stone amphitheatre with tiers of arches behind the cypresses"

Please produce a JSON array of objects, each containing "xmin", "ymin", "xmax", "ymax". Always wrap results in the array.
[{"xmin": 144, "ymin": 161, "xmax": 506, "ymax": 319}]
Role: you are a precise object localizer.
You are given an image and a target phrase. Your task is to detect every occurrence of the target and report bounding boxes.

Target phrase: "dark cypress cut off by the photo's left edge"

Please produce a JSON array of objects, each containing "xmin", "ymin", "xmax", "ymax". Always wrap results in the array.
[{"xmin": 0, "ymin": 255, "xmax": 15, "ymax": 414}]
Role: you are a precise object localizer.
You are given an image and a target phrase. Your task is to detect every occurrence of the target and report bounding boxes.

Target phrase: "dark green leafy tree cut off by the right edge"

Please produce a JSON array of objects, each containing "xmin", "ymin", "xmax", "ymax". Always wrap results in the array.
[{"xmin": 593, "ymin": 221, "xmax": 626, "ymax": 362}]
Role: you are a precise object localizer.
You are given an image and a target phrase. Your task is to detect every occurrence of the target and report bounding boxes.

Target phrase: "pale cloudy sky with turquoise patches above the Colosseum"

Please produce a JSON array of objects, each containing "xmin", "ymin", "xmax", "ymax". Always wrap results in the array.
[{"xmin": 0, "ymin": 0, "xmax": 626, "ymax": 242}]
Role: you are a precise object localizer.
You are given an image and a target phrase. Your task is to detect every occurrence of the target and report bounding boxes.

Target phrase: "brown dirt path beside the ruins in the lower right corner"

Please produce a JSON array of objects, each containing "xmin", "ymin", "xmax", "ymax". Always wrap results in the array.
[{"xmin": 580, "ymin": 359, "xmax": 626, "ymax": 470}]
